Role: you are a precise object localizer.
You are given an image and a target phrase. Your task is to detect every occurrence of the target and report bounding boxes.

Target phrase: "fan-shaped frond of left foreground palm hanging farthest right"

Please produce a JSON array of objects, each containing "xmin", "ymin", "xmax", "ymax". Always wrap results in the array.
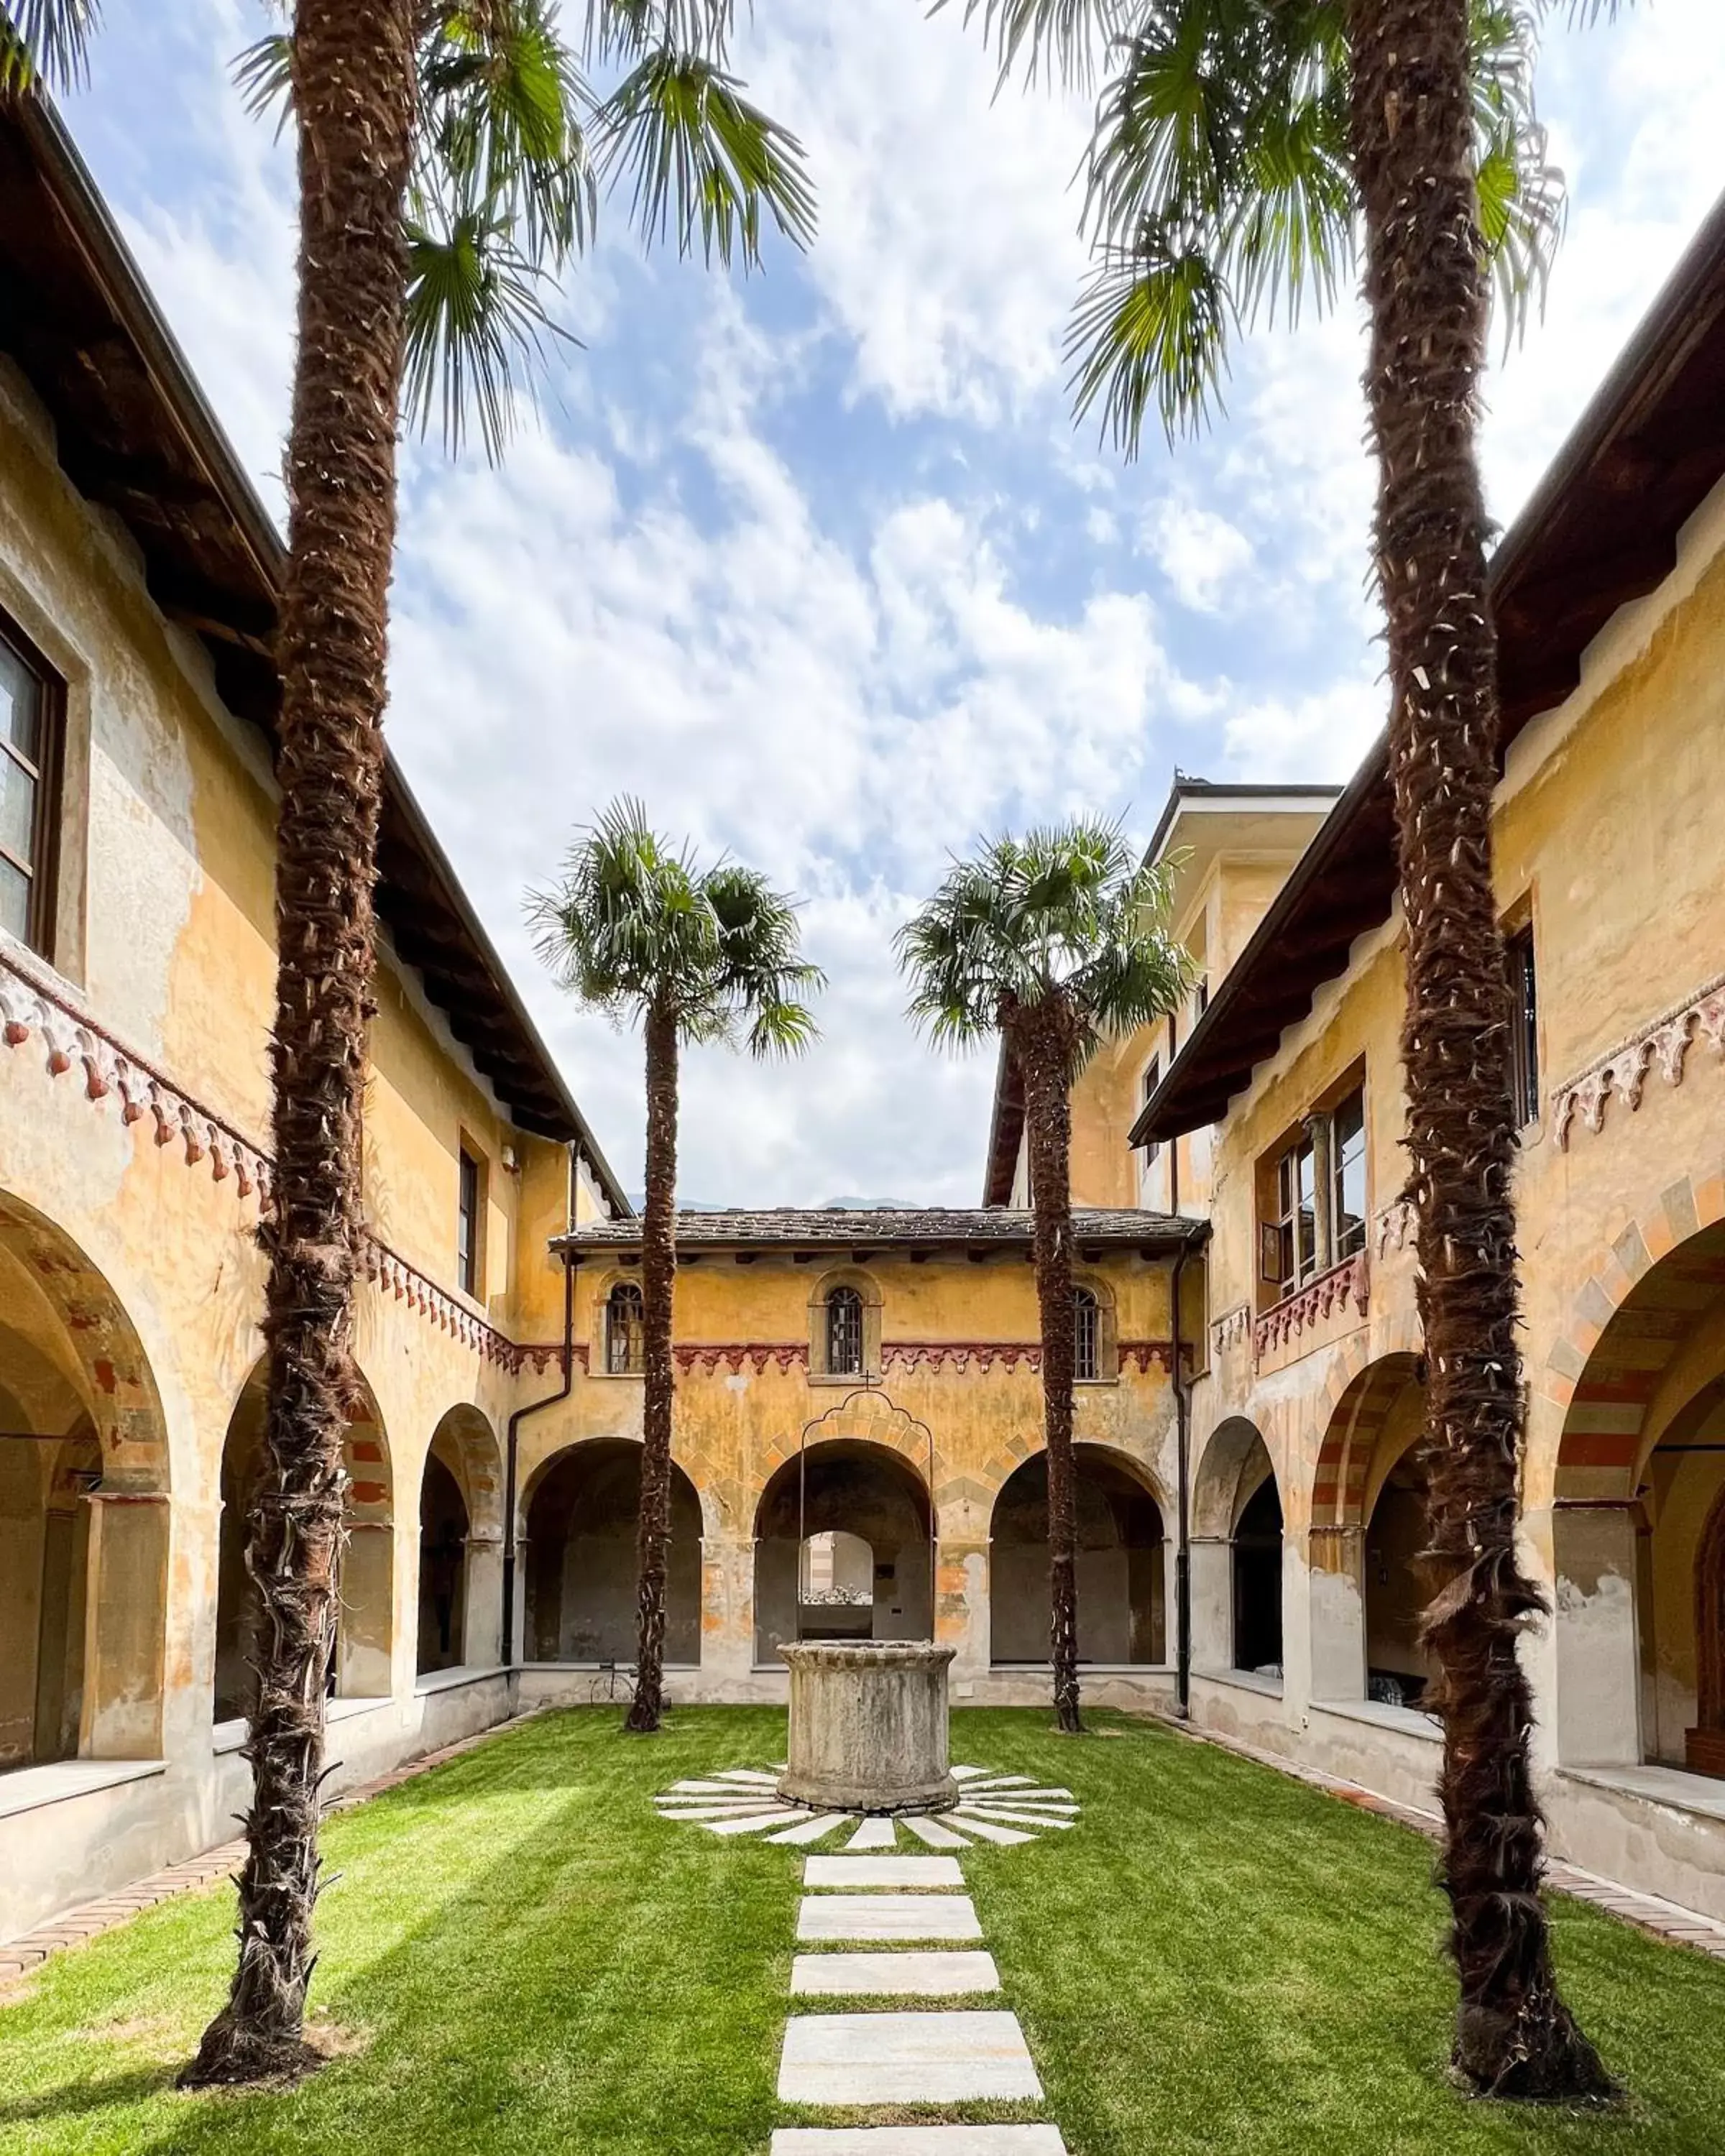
[{"xmin": 597, "ymin": 47, "xmax": 815, "ymax": 267}]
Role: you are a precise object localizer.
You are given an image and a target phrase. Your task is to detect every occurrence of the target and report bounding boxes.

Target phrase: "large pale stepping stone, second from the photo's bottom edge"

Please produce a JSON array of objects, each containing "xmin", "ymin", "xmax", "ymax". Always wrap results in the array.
[{"xmin": 778, "ymin": 2009, "xmax": 1041, "ymax": 2104}]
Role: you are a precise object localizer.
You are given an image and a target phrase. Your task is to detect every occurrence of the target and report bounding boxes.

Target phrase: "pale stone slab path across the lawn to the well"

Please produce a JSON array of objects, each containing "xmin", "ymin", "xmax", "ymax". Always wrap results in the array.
[{"xmin": 772, "ymin": 1820, "xmax": 1072, "ymax": 2156}]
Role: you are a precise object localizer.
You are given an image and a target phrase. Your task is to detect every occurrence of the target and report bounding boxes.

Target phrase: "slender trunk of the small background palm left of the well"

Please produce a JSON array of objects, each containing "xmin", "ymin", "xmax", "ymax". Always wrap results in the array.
[{"xmin": 625, "ymin": 1009, "xmax": 677, "ymax": 1736}]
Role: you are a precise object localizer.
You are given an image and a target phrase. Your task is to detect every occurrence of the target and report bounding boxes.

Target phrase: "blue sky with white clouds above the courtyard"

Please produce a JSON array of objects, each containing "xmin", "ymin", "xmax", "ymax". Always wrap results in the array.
[{"xmin": 67, "ymin": 0, "xmax": 1725, "ymax": 1205}]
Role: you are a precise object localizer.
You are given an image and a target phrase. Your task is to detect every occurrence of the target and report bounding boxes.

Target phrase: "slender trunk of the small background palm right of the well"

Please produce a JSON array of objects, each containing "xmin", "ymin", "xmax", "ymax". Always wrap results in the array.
[{"xmin": 1016, "ymin": 1031, "xmax": 1082, "ymax": 1736}]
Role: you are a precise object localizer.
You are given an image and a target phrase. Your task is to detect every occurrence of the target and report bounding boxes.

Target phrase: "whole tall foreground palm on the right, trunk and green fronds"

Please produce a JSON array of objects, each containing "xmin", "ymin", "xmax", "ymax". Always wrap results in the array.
[{"xmin": 942, "ymin": 0, "xmax": 1611, "ymax": 2098}]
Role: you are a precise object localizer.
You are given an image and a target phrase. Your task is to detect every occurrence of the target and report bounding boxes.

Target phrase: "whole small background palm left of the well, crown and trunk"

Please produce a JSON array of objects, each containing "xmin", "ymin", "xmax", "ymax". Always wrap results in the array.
[{"xmin": 528, "ymin": 800, "xmax": 826, "ymax": 1736}]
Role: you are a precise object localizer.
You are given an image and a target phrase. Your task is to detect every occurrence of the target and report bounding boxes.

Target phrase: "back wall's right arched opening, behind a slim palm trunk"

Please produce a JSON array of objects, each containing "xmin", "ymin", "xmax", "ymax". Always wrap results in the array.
[{"xmin": 988, "ymin": 1442, "xmax": 1167, "ymax": 1667}]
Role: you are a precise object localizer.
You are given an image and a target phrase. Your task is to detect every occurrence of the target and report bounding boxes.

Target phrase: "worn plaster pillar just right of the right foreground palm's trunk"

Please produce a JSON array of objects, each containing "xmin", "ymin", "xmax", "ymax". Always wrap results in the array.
[{"xmin": 1550, "ymin": 1496, "xmax": 1641, "ymax": 1766}]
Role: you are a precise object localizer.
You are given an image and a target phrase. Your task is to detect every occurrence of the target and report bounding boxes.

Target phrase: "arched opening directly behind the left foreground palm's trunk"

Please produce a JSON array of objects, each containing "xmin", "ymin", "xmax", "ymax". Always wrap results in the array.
[{"xmin": 211, "ymin": 1356, "xmax": 395, "ymax": 1723}]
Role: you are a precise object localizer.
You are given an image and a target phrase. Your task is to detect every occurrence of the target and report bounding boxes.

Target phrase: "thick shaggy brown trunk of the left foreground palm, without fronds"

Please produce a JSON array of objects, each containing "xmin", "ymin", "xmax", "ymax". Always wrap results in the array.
[{"xmin": 181, "ymin": 0, "xmax": 416, "ymax": 2085}]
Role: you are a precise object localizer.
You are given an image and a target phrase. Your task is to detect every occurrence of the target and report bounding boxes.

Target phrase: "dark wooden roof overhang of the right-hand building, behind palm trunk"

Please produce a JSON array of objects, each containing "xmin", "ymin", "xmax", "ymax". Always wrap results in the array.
[{"xmin": 1130, "ymin": 181, "xmax": 1725, "ymax": 1145}]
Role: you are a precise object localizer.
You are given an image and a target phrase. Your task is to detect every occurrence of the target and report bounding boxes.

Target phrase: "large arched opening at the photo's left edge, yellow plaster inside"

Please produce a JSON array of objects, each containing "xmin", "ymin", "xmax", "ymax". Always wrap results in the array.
[{"xmin": 0, "ymin": 1192, "xmax": 170, "ymax": 1770}]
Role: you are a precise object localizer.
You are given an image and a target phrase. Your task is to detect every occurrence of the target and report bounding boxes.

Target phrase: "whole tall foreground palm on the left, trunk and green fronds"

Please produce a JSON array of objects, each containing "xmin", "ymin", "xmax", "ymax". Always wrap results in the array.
[{"xmin": 0, "ymin": 0, "xmax": 811, "ymax": 2085}]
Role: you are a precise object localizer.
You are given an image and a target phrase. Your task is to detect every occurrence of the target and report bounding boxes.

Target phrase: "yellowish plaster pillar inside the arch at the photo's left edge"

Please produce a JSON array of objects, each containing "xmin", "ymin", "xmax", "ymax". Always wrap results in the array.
[{"xmin": 78, "ymin": 1490, "xmax": 170, "ymax": 1759}]
